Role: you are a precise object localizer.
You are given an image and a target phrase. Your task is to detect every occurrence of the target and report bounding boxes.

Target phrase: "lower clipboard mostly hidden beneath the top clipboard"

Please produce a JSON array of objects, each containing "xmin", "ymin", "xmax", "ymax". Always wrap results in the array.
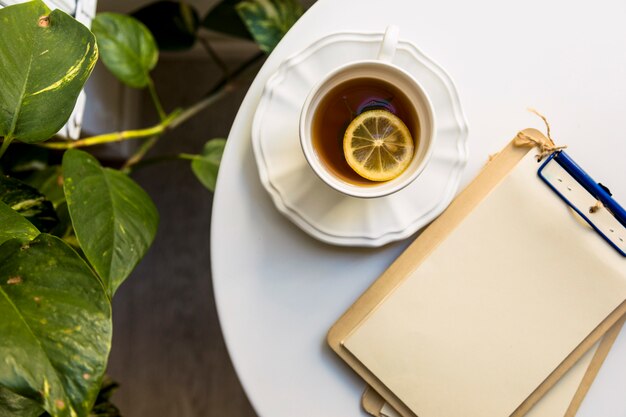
[{"xmin": 361, "ymin": 316, "xmax": 626, "ymax": 417}]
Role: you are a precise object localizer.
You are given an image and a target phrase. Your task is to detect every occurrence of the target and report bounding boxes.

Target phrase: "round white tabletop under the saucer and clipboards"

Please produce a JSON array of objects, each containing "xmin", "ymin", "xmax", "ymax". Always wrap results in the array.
[{"xmin": 211, "ymin": 0, "xmax": 626, "ymax": 417}]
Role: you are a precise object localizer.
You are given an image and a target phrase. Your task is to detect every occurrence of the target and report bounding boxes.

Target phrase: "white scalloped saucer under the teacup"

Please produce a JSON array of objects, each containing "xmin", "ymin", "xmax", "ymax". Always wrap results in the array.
[{"xmin": 252, "ymin": 33, "xmax": 467, "ymax": 247}]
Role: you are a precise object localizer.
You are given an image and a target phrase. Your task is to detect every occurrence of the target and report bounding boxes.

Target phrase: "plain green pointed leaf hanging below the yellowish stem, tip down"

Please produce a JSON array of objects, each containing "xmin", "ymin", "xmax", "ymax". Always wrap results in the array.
[{"xmin": 63, "ymin": 149, "xmax": 159, "ymax": 297}]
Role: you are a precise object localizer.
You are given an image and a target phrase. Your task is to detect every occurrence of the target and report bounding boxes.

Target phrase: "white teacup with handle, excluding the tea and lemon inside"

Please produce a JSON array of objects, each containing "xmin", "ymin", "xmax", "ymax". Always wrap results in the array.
[{"xmin": 300, "ymin": 26, "xmax": 435, "ymax": 198}]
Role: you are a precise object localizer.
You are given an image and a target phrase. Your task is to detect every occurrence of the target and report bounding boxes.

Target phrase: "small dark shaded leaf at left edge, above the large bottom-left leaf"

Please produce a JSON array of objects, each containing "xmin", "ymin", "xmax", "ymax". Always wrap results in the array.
[{"xmin": 0, "ymin": 175, "xmax": 59, "ymax": 232}]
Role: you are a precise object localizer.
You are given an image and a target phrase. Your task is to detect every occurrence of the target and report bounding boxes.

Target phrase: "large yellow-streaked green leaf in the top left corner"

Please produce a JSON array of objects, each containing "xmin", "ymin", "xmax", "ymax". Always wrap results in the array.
[{"xmin": 0, "ymin": 0, "xmax": 98, "ymax": 143}]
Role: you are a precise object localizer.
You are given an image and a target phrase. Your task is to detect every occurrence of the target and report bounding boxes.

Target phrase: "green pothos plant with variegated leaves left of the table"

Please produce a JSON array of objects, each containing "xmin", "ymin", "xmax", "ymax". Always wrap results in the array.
[{"xmin": 0, "ymin": 0, "xmax": 302, "ymax": 417}]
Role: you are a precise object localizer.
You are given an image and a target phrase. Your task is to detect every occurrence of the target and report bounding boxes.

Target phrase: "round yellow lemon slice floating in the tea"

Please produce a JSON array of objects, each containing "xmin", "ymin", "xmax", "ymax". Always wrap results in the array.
[{"xmin": 343, "ymin": 110, "xmax": 414, "ymax": 181}]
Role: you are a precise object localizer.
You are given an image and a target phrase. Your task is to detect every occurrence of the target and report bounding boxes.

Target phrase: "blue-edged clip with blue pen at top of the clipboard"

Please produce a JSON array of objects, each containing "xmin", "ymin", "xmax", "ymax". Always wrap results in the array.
[{"xmin": 537, "ymin": 151, "xmax": 626, "ymax": 257}]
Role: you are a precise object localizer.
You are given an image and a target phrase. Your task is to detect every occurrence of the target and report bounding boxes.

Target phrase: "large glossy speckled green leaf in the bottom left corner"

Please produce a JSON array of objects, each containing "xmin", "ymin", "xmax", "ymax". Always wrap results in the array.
[{"xmin": 0, "ymin": 234, "xmax": 112, "ymax": 417}]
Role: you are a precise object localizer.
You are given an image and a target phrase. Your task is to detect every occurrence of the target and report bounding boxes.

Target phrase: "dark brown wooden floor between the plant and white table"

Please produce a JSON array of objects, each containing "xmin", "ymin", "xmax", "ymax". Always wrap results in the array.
[{"xmin": 109, "ymin": 56, "xmax": 255, "ymax": 417}]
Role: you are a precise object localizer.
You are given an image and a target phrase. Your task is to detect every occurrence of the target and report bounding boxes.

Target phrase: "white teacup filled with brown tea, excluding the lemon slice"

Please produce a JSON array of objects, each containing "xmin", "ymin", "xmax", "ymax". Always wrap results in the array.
[{"xmin": 299, "ymin": 26, "xmax": 435, "ymax": 198}]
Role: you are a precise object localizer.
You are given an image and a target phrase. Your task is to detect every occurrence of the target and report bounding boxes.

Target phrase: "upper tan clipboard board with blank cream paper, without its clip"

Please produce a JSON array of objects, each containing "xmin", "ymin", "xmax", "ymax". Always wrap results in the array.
[{"xmin": 328, "ymin": 129, "xmax": 626, "ymax": 417}]
